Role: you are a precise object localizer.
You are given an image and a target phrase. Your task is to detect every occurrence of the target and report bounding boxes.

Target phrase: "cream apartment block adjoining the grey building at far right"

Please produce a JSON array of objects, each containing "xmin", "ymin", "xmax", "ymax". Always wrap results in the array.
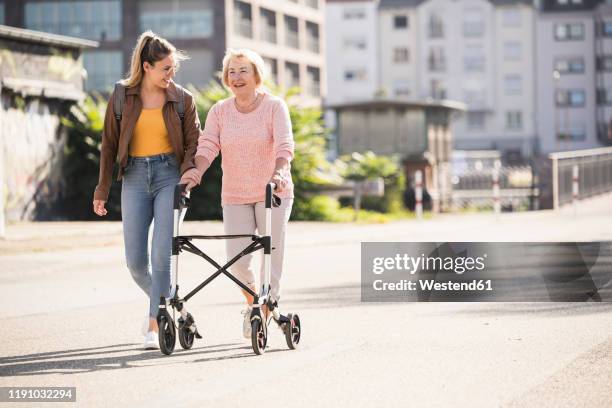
[{"xmin": 379, "ymin": 0, "xmax": 536, "ymax": 156}]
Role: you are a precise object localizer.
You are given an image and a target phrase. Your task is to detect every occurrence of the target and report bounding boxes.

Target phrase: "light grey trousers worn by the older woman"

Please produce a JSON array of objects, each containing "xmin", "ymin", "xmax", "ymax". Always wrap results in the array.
[{"xmin": 223, "ymin": 198, "xmax": 293, "ymax": 300}]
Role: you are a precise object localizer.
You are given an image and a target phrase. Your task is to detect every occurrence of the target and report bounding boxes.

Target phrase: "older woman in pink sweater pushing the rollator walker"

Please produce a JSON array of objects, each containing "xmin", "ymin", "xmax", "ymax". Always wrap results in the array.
[{"xmin": 181, "ymin": 49, "xmax": 294, "ymax": 338}]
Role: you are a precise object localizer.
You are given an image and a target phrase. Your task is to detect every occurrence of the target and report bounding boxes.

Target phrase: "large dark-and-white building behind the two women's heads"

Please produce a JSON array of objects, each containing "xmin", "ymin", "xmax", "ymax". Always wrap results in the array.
[{"xmin": 0, "ymin": 0, "xmax": 325, "ymax": 103}]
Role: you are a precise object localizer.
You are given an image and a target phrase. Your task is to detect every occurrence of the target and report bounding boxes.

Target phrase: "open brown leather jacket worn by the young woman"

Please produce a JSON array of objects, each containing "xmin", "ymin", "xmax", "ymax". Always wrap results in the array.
[{"xmin": 94, "ymin": 82, "xmax": 200, "ymax": 201}]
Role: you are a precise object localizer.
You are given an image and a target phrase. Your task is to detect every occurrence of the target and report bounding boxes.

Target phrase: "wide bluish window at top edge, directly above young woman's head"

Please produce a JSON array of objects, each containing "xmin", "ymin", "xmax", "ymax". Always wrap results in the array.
[{"xmin": 140, "ymin": 0, "xmax": 214, "ymax": 38}]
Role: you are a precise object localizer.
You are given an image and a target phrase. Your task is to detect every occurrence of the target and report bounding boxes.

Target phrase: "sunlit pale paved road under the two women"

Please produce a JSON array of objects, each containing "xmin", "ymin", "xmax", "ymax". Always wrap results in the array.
[{"xmin": 0, "ymin": 196, "xmax": 612, "ymax": 408}]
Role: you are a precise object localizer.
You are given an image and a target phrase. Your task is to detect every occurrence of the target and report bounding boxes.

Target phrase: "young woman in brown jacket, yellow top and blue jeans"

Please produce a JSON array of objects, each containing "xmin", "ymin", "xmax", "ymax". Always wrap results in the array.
[{"xmin": 93, "ymin": 31, "xmax": 200, "ymax": 349}]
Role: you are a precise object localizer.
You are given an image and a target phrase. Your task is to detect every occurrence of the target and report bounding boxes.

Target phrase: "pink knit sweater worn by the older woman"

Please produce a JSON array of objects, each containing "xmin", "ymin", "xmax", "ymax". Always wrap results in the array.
[{"xmin": 196, "ymin": 93, "xmax": 294, "ymax": 205}]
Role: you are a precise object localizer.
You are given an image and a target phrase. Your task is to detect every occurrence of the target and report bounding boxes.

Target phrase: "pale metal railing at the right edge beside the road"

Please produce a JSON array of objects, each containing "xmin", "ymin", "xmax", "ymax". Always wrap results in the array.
[{"xmin": 549, "ymin": 147, "xmax": 612, "ymax": 209}]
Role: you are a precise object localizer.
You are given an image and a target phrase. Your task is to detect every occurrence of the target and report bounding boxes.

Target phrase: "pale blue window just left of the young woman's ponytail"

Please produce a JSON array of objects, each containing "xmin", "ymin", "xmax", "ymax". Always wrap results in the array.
[{"xmin": 83, "ymin": 51, "xmax": 123, "ymax": 91}]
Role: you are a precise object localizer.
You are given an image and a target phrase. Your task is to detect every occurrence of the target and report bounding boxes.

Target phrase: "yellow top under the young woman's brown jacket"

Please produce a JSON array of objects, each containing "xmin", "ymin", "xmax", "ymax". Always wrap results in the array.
[{"xmin": 129, "ymin": 108, "xmax": 174, "ymax": 157}]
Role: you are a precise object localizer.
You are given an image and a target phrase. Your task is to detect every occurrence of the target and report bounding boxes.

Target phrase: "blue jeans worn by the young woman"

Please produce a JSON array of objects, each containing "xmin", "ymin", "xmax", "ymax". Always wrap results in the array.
[{"xmin": 121, "ymin": 154, "xmax": 180, "ymax": 318}]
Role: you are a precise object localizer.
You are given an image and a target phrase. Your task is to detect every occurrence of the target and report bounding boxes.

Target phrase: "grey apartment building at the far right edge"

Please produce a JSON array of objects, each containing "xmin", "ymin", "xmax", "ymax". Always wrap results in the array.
[{"xmin": 536, "ymin": 0, "xmax": 612, "ymax": 152}]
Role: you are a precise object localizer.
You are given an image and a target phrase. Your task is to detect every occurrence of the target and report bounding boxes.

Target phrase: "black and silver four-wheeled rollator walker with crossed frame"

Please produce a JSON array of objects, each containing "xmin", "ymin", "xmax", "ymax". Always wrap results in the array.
[{"xmin": 157, "ymin": 183, "xmax": 301, "ymax": 355}]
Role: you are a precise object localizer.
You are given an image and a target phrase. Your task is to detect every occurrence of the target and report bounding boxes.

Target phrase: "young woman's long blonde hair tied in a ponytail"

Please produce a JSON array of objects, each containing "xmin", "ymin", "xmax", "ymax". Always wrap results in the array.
[{"xmin": 121, "ymin": 30, "xmax": 189, "ymax": 88}]
